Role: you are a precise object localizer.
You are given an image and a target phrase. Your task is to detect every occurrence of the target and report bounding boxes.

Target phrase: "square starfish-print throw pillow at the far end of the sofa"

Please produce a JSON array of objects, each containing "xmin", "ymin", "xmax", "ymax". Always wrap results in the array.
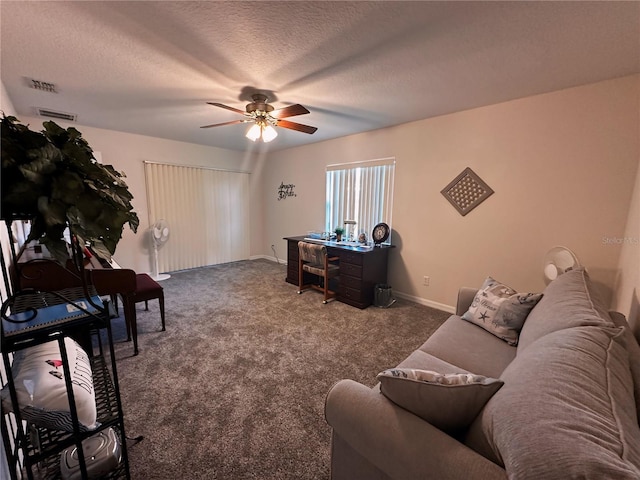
[{"xmin": 462, "ymin": 277, "xmax": 542, "ymax": 345}]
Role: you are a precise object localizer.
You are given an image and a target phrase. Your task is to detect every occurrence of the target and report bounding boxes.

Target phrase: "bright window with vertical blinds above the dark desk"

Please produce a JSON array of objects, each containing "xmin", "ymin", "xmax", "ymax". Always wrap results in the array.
[{"xmin": 325, "ymin": 158, "xmax": 396, "ymax": 243}]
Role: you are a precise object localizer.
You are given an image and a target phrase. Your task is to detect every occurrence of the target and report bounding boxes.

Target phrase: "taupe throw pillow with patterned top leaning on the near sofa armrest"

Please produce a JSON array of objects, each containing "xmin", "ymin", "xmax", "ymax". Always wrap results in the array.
[{"xmin": 377, "ymin": 368, "xmax": 503, "ymax": 432}]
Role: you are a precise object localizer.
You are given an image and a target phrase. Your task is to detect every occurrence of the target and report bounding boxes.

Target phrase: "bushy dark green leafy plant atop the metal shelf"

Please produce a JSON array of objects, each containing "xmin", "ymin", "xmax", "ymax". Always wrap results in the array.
[{"xmin": 0, "ymin": 115, "xmax": 140, "ymax": 262}]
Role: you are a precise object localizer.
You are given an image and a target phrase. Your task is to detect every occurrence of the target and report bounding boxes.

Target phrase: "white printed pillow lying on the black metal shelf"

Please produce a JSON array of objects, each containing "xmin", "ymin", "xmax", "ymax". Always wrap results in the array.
[{"xmin": 0, "ymin": 338, "xmax": 98, "ymax": 431}]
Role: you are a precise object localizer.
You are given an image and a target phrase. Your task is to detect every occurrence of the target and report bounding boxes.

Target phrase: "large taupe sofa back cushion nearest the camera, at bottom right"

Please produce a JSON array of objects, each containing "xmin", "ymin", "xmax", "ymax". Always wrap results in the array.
[{"xmin": 466, "ymin": 326, "xmax": 640, "ymax": 479}]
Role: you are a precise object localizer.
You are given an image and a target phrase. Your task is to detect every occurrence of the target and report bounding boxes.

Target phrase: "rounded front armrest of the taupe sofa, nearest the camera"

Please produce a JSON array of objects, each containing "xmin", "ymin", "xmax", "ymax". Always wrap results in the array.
[{"xmin": 325, "ymin": 380, "xmax": 506, "ymax": 480}]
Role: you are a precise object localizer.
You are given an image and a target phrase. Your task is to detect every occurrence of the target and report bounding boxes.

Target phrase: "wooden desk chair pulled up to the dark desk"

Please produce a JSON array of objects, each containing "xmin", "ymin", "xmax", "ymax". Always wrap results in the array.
[{"xmin": 298, "ymin": 242, "xmax": 340, "ymax": 303}]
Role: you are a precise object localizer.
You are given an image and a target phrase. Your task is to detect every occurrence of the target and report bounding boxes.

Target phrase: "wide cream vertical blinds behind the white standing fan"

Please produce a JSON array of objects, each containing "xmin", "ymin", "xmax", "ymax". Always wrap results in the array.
[{"xmin": 144, "ymin": 162, "xmax": 249, "ymax": 272}]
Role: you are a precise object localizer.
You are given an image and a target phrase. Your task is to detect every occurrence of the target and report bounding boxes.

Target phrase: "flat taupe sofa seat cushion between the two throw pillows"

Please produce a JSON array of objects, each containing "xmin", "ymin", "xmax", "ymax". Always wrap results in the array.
[{"xmin": 420, "ymin": 315, "xmax": 516, "ymax": 378}]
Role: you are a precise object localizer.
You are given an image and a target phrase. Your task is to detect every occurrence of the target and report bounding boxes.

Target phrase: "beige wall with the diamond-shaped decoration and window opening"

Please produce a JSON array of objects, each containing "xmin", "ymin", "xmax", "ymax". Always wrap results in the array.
[{"xmin": 262, "ymin": 76, "xmax": 639, "ymax": 313}]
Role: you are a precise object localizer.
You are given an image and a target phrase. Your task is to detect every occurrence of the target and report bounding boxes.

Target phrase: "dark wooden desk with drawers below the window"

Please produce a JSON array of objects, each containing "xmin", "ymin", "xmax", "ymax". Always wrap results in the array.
[{"xmin": 284, "ymin": 236, "xmax": 393, "ymax": 308}]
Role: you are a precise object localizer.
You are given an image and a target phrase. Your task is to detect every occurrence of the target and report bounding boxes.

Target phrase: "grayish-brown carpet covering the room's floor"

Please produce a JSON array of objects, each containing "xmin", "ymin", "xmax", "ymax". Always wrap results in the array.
[{"xmin": 109, "ymin": 260, "xmax": 448, "ymax": 480}]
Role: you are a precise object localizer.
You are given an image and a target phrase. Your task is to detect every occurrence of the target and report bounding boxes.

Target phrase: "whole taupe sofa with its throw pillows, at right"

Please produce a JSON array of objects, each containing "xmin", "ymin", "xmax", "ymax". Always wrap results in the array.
[{"xmin": 325, "ymin": 268, "xmax": 640, "ymax": 480}]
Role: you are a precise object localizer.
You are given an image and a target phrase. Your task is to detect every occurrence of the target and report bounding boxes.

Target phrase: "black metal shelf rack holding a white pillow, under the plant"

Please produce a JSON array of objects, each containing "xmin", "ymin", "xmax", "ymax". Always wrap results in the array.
[{"xmin": 1, "ymin": 291, "xmax": 130, "ymax": 480}]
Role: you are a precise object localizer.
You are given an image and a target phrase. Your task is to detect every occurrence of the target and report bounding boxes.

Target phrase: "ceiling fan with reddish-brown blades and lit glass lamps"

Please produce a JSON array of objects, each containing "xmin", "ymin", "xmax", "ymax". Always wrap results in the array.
[{"xmin": 200, "ymin": 93, "xmax": 317, "ymax": 142}]
